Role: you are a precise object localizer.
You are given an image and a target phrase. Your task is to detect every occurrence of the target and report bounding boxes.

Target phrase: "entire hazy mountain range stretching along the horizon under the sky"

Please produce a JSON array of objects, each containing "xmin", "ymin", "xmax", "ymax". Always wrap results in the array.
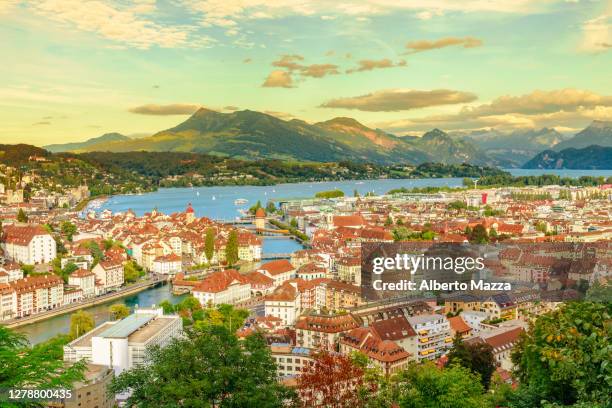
[{"xmin": 45, "ymin": 108, "xmax": 612, "ymax": 167}]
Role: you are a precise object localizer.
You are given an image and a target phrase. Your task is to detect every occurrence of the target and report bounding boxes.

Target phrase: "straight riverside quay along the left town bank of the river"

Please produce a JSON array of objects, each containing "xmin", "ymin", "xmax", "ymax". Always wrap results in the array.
[{"xmin": 0, "ymin": 279, "xmax": 165, "ymax": 329}]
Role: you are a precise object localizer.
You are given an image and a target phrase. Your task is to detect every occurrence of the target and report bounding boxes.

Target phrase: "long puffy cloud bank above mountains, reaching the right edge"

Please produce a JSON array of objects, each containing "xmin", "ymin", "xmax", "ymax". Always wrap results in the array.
[{"xmin": 377, "ymin": 89, "xmax": 612, "ymax": 132}]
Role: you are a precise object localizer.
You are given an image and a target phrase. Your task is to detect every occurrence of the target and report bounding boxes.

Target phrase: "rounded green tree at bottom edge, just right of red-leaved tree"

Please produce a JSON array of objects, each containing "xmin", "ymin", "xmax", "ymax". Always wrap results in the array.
[{"xmin": 395, "ymin": 362, "xmax": 490, "ymax": 408}]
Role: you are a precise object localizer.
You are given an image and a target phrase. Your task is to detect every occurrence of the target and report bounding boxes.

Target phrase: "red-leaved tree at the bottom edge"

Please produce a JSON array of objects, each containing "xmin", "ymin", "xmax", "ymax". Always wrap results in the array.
[{"xmin": 297, "ymin": 351, "xmax": 364, "ymax": 408}]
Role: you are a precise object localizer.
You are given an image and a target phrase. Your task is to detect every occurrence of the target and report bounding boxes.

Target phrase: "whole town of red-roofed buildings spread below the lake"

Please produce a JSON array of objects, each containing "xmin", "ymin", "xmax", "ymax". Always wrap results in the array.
[{"xmin": 0, "ymin": 158, "xmax": 612, "ymax": 406}]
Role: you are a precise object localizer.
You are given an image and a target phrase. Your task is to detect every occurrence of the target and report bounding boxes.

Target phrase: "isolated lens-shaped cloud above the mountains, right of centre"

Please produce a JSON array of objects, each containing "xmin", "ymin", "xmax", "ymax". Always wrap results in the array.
[{"xmin": 320, "ymin": 89, "xmax": 477, "ymax": 112}]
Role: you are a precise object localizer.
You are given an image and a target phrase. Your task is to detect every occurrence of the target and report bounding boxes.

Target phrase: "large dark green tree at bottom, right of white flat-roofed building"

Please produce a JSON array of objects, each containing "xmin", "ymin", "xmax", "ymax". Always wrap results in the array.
[{"xmin": 109, "ymin": 326, "xmax": 293, "ymax": 408}]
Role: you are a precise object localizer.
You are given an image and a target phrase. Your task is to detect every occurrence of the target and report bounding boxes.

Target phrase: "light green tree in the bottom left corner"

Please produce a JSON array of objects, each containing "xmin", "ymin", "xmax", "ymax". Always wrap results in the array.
[{"xmin": 0, "ymin": 325, "xmax": 85, "ymax": 396}]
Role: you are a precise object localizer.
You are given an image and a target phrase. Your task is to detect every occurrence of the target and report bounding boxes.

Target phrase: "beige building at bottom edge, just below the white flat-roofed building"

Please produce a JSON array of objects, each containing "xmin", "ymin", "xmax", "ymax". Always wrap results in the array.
[{"xmin": 64, "ymin": 363, "xmax": 115, "ymax": 408}]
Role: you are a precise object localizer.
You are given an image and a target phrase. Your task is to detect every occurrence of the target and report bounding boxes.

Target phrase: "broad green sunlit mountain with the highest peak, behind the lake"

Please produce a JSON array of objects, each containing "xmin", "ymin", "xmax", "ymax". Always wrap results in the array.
[{"xmin": 67, "ymin": 108, "xmax": 495, "ymax": 164}]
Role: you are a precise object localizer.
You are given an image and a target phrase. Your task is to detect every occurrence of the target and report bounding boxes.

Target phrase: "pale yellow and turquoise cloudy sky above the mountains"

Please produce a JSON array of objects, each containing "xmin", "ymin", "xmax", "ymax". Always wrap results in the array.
[{"xmin": 0, "ymin": 0, "xmax": 612, "ymax": 146}]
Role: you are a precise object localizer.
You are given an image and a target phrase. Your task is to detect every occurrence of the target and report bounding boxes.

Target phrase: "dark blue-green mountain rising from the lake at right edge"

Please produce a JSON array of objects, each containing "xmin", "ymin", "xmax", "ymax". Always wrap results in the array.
[{"xmin": 523, "ymin": 145, "xmax": 612, "ymax": 170}]
